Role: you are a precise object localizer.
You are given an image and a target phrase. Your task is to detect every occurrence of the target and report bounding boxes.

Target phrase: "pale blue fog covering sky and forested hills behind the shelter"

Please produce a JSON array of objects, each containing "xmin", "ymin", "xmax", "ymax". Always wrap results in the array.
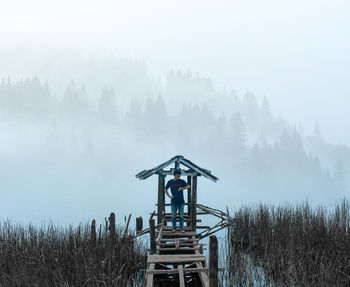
[{"xmin": 0, "ymin": 1, "xmax": 350, "ymax": 227}]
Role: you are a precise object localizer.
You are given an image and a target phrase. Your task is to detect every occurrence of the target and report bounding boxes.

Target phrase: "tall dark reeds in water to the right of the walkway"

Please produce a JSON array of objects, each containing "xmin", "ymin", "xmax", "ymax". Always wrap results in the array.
[{"xmin": 225, "ymin": 199, "xmax": 350, "ymax": 286}]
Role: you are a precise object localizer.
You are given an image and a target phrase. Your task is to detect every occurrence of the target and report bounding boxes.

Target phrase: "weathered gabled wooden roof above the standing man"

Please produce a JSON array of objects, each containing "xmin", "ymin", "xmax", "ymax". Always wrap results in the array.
[{"xmin": 135, "ymin": 155, "xmax": 219, "ymax": 182}]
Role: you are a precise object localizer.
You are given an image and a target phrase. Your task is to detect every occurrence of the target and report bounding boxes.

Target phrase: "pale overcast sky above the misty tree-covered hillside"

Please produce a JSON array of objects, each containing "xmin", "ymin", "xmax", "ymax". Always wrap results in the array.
[{"xmin": 0, "ymin": 0, "xmax": 350, "ymax": 145}]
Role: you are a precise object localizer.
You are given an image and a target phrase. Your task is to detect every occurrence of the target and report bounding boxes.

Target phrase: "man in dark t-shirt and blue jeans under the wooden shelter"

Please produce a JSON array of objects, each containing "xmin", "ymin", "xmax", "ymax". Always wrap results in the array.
[{"xmin": 164, "ymin": 169, "xmax": 191, "ymax": 232}]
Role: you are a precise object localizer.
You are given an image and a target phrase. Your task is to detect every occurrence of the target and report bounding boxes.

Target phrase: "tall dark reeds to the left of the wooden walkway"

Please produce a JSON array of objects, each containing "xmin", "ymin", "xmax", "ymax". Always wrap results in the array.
[{"xmin": 0, "ymin": 220, "xmax": 147, "ymax": 286}]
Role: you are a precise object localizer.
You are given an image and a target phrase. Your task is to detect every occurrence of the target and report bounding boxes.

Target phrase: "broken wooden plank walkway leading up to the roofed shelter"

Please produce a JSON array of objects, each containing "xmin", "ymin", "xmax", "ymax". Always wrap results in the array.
[{"xmin": 146, "ymin": 220, "xmax": 209, "ymax": 287}]
